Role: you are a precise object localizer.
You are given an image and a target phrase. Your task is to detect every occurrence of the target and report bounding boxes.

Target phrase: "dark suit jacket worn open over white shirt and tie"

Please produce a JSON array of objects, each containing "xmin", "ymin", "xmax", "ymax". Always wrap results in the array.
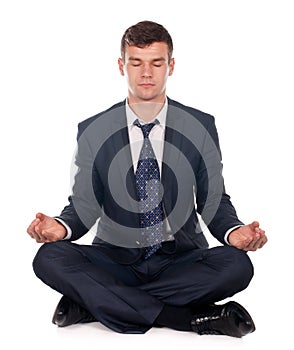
[{"xmin": 59, "ymin": 99, "xmax": 243, "ymax": 264}]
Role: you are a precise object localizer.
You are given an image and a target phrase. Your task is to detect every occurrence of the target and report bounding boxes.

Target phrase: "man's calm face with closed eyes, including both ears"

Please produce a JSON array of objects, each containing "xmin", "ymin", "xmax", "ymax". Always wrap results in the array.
[{"xmin": 118, "ymin": 42, "xmax": 174, "ymax": 104}]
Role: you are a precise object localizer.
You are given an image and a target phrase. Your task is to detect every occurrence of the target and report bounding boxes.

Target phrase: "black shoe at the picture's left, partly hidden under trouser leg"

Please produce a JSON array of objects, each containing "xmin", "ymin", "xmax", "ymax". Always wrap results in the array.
[{"xmin": 52, "ymin": 296, "xmax": 96, "ymax": 327}]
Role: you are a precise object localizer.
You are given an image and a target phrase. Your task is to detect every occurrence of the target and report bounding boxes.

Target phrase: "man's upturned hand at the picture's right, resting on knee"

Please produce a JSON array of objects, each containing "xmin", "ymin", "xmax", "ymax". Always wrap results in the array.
[{"xmin": 228, "ymin": 221, "xmax": 267, "ymax": 251}]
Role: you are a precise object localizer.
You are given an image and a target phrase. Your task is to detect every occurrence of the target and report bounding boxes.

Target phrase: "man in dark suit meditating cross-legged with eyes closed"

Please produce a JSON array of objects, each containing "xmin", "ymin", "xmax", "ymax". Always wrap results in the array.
[{"xmin": 27, "ymin": 21, "xmax": 267, "ymax": 337}]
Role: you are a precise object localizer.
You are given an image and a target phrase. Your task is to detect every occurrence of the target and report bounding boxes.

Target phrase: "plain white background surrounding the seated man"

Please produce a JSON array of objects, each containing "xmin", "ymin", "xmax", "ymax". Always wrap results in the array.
[{"xmin": 0, "ymin": 0, "xmax": 294, "ymax": 349}]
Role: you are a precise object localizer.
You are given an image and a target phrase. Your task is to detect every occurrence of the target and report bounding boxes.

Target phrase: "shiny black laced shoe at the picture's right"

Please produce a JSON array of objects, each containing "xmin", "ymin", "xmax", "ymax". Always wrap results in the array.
[{"xmin": 191, "ymin": 301, "xmax": 255, "ymax": 338}]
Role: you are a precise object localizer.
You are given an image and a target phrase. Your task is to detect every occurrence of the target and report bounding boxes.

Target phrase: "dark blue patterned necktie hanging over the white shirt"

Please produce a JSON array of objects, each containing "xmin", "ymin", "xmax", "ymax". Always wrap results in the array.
[{"xmin": 134, "ymin": 119, "xmax": 164, "ymax": 259}]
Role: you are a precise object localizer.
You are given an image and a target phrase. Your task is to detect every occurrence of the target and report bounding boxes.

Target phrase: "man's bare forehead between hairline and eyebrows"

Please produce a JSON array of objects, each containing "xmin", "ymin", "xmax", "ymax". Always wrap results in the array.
[{"xmin": 125, "ymin": 42, "xmax": 168, "ymax": 61}]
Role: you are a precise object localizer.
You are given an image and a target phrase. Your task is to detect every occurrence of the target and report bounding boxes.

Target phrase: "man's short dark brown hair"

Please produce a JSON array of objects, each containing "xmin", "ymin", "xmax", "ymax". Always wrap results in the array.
[{"xmin": 120, "ymin": 21, "xmax": 173, "ymax": 61}]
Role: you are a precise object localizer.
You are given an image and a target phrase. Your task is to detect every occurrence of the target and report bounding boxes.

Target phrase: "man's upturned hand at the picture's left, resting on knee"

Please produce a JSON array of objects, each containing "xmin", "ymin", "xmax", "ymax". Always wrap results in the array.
[{"xmin": 27, "ymin": 213, "xmax": 67, "ymax": 243}]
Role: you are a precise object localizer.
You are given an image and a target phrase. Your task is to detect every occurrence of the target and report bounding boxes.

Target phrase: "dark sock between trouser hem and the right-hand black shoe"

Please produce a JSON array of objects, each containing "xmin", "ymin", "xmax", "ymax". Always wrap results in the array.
[{"xmin": 155, "ymin": 305, "xmax": 193, "ymax": 331}]
